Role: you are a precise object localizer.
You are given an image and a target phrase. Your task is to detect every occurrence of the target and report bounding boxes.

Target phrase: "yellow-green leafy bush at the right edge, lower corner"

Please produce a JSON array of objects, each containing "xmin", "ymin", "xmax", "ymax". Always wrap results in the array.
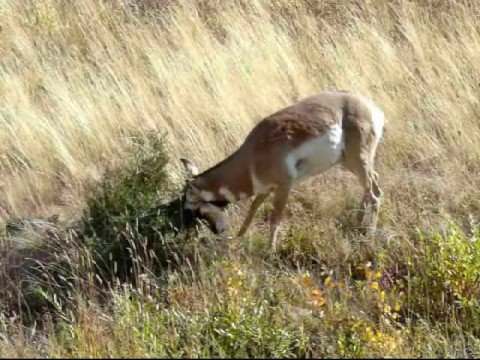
[{"xmin": 407, "ymin": 223, "xmax": 480, "ymax": 333}]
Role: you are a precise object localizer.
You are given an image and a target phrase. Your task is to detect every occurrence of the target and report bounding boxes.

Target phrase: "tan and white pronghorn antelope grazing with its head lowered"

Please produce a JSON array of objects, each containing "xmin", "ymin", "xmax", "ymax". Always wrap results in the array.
[{"xmin": 181, "ymin": 91, "xmax": 384, "ymax": 249}]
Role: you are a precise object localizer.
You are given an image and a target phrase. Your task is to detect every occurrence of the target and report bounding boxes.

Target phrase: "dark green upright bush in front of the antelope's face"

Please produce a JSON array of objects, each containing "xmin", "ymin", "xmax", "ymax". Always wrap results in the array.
[{"xmin": 84, "ymin": 133, "xmax": 188, "ymax": 280}]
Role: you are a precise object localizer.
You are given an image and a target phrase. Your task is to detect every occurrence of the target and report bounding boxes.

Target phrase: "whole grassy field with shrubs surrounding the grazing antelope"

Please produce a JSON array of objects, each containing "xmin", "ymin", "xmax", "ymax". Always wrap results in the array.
[{"xmin": 0, "ymin": 0, "xmax": 480, "ymax": 357}]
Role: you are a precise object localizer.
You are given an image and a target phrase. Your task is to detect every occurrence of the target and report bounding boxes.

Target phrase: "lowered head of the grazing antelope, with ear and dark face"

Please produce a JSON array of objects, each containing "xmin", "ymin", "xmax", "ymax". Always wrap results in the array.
[{"xmin": 180, "ymin": 159, "xmax": 229, "ymax": 234}]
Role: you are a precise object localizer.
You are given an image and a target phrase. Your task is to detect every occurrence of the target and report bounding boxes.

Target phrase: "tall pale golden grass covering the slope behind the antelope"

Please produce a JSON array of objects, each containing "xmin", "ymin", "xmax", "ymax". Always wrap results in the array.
[{"xmin": 0, "ymin": 0, "xmax": 480, "ymax": 217}]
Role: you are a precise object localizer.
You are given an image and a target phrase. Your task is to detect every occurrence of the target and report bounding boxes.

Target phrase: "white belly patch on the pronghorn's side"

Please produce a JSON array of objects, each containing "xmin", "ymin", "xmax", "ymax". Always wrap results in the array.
[{"xmin": 285, "ymin": 124, "xmax": 345, "ymax": 182}]
